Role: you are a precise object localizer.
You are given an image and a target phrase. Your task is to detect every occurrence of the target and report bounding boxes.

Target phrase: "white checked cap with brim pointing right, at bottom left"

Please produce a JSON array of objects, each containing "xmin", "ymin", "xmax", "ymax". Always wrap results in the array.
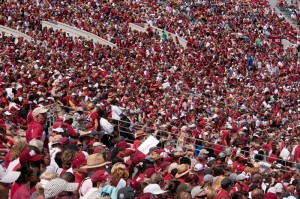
[{"xmin": 44, "ymin": 178, "xmax": 78, "ymax": 198}]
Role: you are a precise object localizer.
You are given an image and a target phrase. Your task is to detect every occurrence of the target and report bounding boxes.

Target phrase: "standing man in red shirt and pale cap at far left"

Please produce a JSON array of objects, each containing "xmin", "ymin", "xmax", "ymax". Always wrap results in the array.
[{"xmin": 26, "ymin": 107, "xmax": 48, "ymax": 146}]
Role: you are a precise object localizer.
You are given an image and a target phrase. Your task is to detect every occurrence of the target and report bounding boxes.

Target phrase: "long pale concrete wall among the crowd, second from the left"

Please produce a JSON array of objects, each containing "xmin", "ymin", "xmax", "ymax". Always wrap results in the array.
[{"xmin": 42, "ymin": 21, "xmax": 116, "ymax": 48}]
